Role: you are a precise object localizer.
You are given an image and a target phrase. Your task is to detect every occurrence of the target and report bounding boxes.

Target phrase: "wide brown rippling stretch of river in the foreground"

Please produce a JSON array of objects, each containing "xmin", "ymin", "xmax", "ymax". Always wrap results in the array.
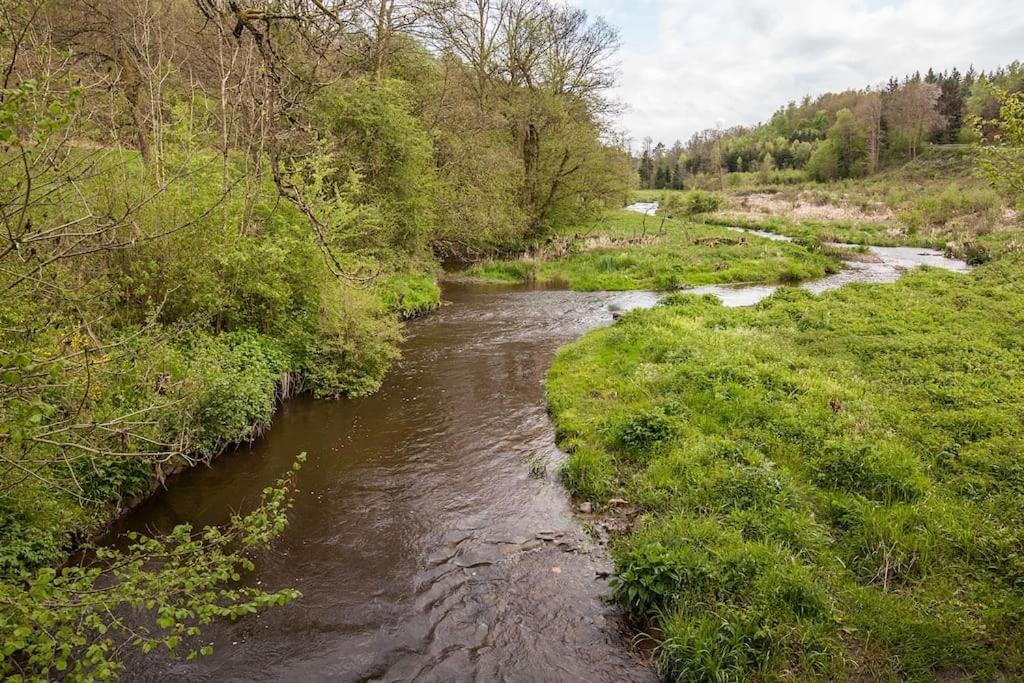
[{"xmin": 110, "ymin": 286, "xmax": 656, "ymax": 681}]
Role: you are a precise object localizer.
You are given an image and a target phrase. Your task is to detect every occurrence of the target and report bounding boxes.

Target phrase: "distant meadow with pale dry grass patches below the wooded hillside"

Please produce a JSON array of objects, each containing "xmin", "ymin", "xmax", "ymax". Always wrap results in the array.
[{"xmin": 633, "ymin": 144, "xmax": 1024, "ymax": 263}]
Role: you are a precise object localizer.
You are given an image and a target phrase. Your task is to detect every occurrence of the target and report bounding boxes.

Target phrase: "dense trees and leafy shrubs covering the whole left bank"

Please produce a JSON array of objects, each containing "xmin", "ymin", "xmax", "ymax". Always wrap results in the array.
[{"xmin": 0, "ymin": 0, "xmax": 632, "ymax": 678}]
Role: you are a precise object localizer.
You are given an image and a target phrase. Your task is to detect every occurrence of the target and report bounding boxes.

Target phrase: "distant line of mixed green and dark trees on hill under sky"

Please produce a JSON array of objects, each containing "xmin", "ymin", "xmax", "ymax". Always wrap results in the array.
[{"xmin": 634, "ymin": 61, "xmax": 1024, "ymax": 189}]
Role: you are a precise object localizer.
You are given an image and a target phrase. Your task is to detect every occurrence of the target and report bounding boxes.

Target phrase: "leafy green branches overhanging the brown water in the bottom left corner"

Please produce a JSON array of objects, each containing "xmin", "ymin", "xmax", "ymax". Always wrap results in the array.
[{"xmin": 0, "ymin": 454, "xmax": 305, "ymax": 681}]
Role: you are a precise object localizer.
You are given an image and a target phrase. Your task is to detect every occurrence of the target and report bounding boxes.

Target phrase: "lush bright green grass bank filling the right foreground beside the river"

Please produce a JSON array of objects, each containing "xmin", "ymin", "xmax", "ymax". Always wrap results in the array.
[{"xmin": 548, "ymin": 256, "xmax": 1024, "ymax": 680}]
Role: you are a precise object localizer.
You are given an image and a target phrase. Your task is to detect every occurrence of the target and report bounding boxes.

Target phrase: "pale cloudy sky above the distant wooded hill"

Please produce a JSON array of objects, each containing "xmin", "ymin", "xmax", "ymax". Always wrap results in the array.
[{"xmin": 568, "ymin": 0, "xmax": 1024, "ymax": 146}]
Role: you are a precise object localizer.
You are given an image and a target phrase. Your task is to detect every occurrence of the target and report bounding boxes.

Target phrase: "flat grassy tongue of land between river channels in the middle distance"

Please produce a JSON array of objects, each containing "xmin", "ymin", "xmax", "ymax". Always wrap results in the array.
[{"xmin": 466, "ymin": 211, "xmax": 840, "ymax": 291}]
